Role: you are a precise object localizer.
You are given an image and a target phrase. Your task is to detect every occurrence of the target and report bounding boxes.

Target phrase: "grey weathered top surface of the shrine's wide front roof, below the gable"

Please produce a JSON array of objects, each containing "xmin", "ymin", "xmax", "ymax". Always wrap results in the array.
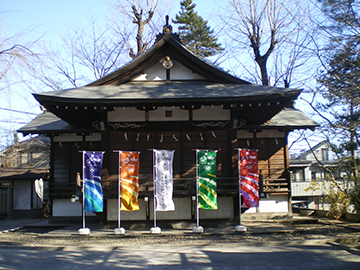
[{"xmin": 34, "ymin": 81, "xmax": 301, "ymax": 106}]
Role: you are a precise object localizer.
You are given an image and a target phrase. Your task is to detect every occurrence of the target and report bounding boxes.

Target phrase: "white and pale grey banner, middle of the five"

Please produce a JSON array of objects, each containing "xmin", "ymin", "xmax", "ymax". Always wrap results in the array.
[{"xmin": 154, "ymin": 150, "xmax": 175, "ymax": 211}]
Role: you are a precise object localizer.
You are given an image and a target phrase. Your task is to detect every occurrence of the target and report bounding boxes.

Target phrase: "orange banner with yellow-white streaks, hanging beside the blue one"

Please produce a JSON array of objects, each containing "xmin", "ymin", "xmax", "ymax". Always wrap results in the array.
[{"xmin": 120, "ymin": 152, "xmax": 139, "ymax": 211}]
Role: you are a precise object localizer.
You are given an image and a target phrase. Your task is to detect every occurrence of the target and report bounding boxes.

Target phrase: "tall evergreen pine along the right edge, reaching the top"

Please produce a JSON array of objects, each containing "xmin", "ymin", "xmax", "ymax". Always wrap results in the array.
[{"xmin": 318, "ymin": 0, "xmax": 360, "ymax": 179}]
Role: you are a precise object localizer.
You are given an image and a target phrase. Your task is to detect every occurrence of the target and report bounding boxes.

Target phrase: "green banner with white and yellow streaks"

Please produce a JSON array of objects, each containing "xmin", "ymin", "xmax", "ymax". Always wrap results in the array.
[{"xmin": 198, "ymin": 150, "xmax": 218, "ymax": 210}]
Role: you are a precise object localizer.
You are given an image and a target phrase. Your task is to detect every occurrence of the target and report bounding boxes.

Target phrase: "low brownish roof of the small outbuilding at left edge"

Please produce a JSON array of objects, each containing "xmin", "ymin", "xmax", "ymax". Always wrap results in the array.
[{"xmin": 0, "ymin": 168, "xmax": 49, "ymax": 180}]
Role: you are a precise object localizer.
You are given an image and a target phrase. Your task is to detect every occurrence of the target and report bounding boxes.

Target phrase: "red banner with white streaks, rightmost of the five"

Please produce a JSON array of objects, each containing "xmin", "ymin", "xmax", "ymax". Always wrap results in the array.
[{"xmin": 239, "ymin": 149, "xmax": 259, "ymax": 208}]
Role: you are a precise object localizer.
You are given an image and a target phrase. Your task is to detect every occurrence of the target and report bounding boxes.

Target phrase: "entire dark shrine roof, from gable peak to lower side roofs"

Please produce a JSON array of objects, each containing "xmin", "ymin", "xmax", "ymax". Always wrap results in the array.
[{"xmin": 19, "ymin": 35, "xmax": 313, "ymax": 133}]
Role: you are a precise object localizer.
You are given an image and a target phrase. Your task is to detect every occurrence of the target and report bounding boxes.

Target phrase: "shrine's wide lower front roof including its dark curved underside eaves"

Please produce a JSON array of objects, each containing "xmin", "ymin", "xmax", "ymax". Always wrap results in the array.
[{"xmin": 34, "ymin": 82, "xmax": 301, "ymax": 129}]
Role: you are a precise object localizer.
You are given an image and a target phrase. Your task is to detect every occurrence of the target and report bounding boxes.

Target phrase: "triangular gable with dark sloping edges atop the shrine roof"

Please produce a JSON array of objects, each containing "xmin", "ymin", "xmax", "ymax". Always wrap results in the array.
[{"xmin": 88, "ymin": 35, "xmax": 250, "ymax": 86}]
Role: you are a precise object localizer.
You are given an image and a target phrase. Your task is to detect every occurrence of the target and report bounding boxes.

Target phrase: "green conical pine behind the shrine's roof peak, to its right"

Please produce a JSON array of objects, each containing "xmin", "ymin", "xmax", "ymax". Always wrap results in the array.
[{"xmin": 173, "ymin": 0, "xmax": 224, "ymax": 57}]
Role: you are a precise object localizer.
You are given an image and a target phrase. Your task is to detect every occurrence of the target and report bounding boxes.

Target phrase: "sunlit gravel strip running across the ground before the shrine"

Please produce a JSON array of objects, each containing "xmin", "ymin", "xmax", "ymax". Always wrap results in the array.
[{"xmin": 0, "ymin": 222, "xmax": 360, "ymax": 250}]
